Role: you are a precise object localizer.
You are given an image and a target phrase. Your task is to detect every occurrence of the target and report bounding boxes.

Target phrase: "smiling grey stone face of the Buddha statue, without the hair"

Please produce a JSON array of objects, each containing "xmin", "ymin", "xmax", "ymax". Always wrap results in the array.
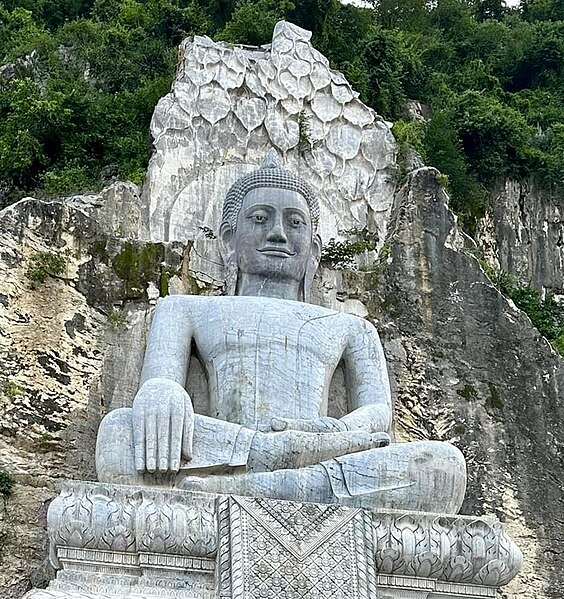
[{"xmin": 233, "ymin": 188, "xmax": 313, "ymax": 282}]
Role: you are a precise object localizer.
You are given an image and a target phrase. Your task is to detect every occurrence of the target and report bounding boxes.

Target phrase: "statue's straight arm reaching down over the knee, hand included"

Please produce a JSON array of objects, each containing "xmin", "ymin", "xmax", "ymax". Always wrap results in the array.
[{"xmin": 132, "ymin": 296, "xmax": 194, "ymax": 472}]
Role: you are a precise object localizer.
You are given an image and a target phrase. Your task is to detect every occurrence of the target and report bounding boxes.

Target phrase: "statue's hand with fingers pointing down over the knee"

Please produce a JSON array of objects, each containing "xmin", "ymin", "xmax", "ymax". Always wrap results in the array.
[{"xmin": 133, "ymin": 378, "xmax": 194, "ymax": 472}]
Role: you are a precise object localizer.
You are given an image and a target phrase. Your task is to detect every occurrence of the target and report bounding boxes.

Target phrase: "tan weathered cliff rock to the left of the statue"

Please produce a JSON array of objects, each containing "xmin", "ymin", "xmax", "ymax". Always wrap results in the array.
[{"xmin": 0, "ymin": 190, "xmax": 189, "ymax": 599}]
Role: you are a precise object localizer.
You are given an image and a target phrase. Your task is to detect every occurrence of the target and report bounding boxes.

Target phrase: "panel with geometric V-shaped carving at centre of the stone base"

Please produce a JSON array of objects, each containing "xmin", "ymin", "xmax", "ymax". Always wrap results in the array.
[{"xmin": 219, "ymin": 496, "xmax": 377, "ymax": 599}]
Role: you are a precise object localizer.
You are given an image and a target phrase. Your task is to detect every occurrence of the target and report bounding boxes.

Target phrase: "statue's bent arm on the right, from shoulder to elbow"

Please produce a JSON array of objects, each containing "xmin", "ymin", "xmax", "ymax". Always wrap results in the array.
[{"xmin": 341, "ymin": 318, "xmax": 392, "ymax": 433}]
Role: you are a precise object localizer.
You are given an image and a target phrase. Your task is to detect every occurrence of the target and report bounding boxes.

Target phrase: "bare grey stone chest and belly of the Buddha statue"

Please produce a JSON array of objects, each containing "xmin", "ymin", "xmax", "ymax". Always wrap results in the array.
[{"xmin": 186, "ymin": 296, "xmax": 353, "ymax": 431}]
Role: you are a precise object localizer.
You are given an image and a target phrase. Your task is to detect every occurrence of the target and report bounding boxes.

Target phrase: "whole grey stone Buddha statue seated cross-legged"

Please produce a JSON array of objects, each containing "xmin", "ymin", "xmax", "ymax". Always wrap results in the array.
[{"xmin": 96, "ymin": 151, "xmax": 466, "ymax": 513}]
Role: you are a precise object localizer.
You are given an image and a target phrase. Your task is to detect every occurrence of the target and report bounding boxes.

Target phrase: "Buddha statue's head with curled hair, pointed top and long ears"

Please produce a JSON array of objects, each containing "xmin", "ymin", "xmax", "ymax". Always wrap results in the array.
[{"xmin": 220, "ymin": 150, "xmax": 321, "ymax": 301}]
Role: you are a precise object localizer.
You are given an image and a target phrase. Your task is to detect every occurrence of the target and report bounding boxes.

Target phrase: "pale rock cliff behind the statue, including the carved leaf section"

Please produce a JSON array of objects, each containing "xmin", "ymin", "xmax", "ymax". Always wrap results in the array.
[{"xmin": 0, "ymin": 24, "xmax": 564, "ymax": 599}]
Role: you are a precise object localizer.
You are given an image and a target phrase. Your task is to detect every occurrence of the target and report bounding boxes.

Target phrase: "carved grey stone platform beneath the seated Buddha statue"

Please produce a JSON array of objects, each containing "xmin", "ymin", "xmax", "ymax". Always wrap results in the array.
[{"xmin": 26, "ymin": 482, "xmax": 522, "ymax": 599}]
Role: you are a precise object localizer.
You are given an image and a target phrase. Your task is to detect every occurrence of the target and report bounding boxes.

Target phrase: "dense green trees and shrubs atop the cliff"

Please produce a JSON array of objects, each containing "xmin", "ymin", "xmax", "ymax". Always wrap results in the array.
[{"xmin": 0, "ymin": 0, "xmax": 564, "ymax": 220}]
